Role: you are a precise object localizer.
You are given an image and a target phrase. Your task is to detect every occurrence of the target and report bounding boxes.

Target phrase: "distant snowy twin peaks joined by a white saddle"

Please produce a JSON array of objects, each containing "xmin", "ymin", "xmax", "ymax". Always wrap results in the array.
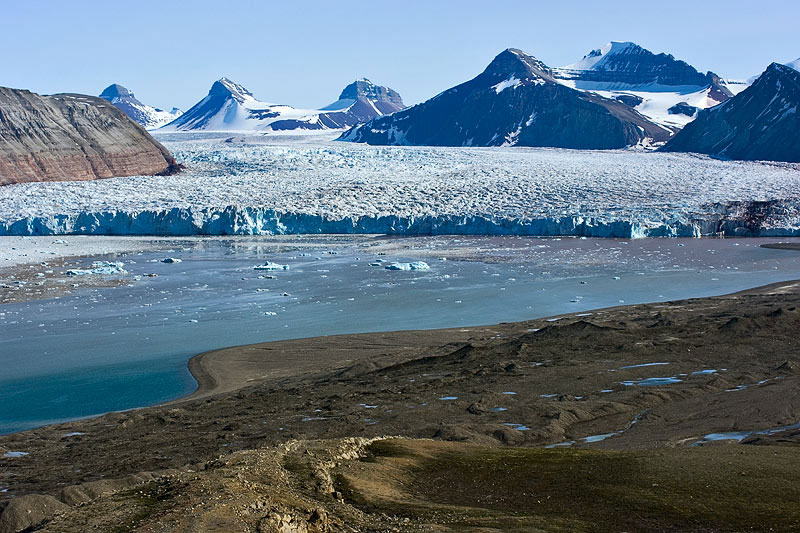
[{"xmin": 161, "ymin": 78, "xmax": 404, "ymax": 131}]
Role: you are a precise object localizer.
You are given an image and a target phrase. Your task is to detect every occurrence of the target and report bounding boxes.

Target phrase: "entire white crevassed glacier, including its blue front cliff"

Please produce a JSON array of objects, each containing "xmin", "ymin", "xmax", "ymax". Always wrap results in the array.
[{"xmin": 0, "ymin": 134, "xmax": 800, "ymax": 238}]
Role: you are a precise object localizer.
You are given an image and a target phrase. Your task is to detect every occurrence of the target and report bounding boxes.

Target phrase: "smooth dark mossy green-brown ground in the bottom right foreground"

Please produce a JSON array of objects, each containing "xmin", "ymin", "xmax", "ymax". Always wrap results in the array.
[{"xmin": 342, "ymin": 440, "xmax": 800, "ymax": 531}]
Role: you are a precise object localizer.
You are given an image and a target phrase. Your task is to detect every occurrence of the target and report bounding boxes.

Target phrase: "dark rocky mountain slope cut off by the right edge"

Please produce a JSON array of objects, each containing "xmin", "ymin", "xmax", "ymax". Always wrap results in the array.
[{"xmin": 662, "ymin": 63, "xmax": 800, "ymax": 162}]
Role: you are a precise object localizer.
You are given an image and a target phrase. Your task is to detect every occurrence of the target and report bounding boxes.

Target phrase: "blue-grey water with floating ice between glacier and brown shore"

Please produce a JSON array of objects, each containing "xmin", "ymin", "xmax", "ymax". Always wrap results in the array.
[{"xmin": 0, "ymin": 237, "xmax": 800, "ymax": 433}]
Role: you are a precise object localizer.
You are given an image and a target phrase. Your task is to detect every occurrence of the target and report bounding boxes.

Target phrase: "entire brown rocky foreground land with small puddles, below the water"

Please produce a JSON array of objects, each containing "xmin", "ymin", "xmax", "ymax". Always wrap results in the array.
[{"xmin": 0, "ymin": 282, "xmax": 800, "ymax": 532}]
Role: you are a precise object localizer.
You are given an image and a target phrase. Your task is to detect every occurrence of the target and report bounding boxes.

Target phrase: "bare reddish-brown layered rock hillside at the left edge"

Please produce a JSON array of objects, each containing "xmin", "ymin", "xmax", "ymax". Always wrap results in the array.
[{"xmin": 0, "ymin": 87, "xmax": 179, "ymax": 185}]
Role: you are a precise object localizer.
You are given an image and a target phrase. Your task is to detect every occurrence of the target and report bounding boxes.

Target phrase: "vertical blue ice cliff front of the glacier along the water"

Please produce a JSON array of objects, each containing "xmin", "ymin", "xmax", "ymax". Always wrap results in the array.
[{"xmin": 0, "ymin": 201, "xmax": 800, "ymax": 238}]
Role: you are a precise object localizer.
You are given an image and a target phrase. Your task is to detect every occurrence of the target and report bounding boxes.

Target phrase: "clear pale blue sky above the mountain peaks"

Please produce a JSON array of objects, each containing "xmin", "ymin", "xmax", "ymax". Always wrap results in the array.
[{"xmin": 0, "ymin": 0, "xmax": 800, "ymax": 110}]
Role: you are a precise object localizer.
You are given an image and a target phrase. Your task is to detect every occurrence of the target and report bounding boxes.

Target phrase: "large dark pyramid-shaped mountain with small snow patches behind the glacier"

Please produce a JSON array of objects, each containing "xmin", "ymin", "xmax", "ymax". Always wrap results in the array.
[{"xmin": 340, "ymin": 49, "xmax": 670, "ymax": 148}]
